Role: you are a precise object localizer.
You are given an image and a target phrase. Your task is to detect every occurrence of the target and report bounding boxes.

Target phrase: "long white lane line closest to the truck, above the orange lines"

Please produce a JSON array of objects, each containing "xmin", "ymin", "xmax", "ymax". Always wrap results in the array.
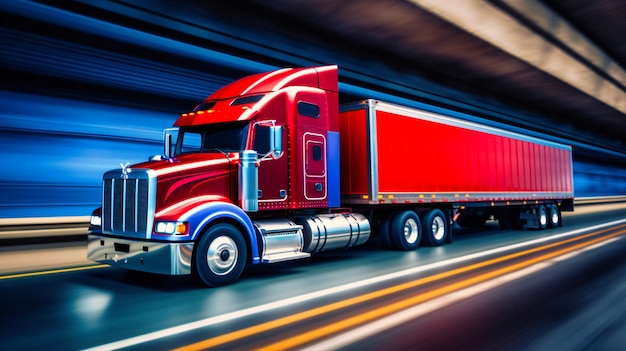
[{"xmin": 85, "ymin": 219, "xmax": 626, "ymax": 351}]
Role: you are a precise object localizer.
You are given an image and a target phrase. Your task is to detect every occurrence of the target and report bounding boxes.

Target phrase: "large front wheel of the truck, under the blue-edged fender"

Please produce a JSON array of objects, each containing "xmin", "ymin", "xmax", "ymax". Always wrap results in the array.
[{"xmin": 192, "ymin": 223, "xmax": 248, "ymax": 287}]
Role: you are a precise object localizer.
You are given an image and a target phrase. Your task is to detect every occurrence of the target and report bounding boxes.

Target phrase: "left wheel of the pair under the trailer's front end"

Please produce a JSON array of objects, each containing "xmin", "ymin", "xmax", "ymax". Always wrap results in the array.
[{"xmin": 389, "ymin": 211, "xmax": 422, "ymax": 251}]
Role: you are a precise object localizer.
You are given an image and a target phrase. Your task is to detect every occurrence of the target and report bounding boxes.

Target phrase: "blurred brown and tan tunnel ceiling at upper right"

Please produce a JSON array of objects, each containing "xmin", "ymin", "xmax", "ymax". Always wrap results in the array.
[{"xmin": 239, "ymin": 0, "xmax": 626, "ymax": 152}]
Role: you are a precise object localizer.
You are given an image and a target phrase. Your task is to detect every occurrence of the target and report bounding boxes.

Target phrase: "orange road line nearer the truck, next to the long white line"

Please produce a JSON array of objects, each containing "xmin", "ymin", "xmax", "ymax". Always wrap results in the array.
[{"xmin": 176, "ymin": 228, "xmax": 626, "ymax": 351}]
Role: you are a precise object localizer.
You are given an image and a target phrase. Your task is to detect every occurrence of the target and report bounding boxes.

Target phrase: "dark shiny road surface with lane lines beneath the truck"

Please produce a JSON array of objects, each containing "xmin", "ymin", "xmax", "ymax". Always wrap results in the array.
[{"xmin": 0, "ymin": 204, "xmax": 626, "ymax": 350}]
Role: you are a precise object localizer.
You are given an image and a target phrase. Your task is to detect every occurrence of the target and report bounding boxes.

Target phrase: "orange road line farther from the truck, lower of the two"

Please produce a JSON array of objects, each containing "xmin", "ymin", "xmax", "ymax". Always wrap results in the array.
[{"xmin": 257, "ymin": 230, "xmax": 626, "ymax": 351}]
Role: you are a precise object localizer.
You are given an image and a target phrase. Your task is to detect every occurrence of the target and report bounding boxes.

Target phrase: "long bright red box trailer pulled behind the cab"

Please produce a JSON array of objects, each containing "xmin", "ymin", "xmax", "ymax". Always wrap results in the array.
[{"xmin": 339, "ymin": 100, "xmax": 573, "ymax": 248}]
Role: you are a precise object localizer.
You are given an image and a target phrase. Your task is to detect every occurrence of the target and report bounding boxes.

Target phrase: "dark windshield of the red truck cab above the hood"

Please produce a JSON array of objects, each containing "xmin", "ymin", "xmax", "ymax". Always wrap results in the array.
[{"xmin": 175, "ymin": 122, "xmax": 248, "ymax": 155}]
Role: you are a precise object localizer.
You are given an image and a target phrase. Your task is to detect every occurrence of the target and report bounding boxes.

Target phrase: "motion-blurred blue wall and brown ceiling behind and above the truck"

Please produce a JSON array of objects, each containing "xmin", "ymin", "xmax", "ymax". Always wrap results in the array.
[{"xmin": 0, "ymin": 0, "xmax": 626, "ymax": 218}]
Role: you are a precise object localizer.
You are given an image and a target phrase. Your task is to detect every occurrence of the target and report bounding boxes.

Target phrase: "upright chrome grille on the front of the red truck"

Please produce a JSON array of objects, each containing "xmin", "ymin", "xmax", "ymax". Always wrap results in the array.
[{"xmin": 102, "ymin": 170, "xmax": 154, "ymax": 238}]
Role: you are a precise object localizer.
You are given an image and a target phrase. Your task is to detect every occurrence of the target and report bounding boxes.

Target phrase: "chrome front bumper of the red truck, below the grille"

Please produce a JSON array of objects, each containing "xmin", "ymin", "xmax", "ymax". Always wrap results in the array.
[{"xmin": 87, "ymin": 234, "xmax": 194, "ymax": 275}]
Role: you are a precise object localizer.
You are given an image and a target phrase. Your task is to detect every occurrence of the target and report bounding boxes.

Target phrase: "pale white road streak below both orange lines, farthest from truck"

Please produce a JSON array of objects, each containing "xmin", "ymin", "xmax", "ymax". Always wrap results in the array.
[{"xmin": 301, "ymin": 237, "xmax": 621, "ymax": 351}]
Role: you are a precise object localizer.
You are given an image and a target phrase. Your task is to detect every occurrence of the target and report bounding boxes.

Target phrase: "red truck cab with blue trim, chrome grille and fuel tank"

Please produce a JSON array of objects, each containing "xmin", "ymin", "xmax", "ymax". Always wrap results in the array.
[{"xmin": 88, "ymin": 66, "xmax": 370, "ymax": 286}]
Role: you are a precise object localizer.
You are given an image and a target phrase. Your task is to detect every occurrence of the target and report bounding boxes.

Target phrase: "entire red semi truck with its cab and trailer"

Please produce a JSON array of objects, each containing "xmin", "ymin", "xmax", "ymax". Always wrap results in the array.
[{"xmin": 88, "ymin": 66, "xmax": 573, "ymax": 286}]
